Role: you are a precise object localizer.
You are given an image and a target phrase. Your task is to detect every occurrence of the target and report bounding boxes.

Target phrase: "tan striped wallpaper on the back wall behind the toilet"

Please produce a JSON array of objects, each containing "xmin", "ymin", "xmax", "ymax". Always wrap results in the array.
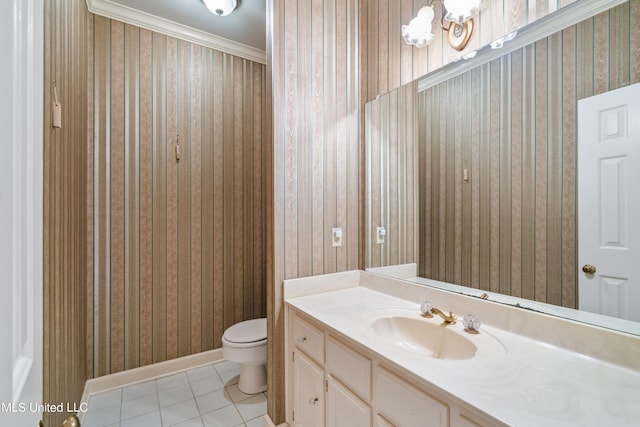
[{"xmin": 88, "ymin": 16, "xmax": 269, "ymax": 377}]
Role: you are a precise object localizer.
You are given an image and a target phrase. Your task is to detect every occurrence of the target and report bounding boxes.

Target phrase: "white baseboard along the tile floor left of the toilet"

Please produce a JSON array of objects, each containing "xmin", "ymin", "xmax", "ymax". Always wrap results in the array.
[{"xmin": 78, "ymin": 348, "xmax": 224, "ymax": 425}]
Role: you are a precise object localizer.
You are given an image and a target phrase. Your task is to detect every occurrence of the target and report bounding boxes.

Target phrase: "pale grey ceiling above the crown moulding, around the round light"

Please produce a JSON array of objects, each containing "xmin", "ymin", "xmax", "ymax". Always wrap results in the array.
[{"xmin": 111, "ymin": 0, "xmax": 267, "ymax": 50}]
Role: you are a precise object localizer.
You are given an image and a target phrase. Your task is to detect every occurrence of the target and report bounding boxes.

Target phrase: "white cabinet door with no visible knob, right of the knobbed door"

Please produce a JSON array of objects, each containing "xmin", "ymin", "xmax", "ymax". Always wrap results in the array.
[{"xmin": 327, "ymin": 377, "xmax": 371, "ymax": 427}]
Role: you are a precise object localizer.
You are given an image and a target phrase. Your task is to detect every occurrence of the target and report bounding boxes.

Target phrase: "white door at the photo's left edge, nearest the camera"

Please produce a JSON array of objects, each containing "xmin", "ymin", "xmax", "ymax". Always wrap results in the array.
[{"xmin": 0, "ymin": 0, "xmax": 44, "ymax": 427}]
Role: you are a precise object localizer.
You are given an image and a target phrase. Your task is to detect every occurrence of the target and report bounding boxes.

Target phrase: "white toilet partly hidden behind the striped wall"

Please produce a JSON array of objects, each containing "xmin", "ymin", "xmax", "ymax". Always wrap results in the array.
[{"xmin": 222, "ymin": 318, "xmax": 267, "ymax": 394}]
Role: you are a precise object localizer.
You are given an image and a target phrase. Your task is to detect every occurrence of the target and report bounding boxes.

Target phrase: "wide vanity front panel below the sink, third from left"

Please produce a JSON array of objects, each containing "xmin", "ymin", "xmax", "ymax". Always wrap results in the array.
[{"xmin": 373, "ymin": 366, "xmax": 449, "ymax": 427}]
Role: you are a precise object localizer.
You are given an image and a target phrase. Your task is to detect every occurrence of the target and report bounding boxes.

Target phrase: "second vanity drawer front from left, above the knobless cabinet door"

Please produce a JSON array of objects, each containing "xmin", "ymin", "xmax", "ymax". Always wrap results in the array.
[{"xmin": 327, "ymin": 337, "xmax": 371, "ymax": 400}]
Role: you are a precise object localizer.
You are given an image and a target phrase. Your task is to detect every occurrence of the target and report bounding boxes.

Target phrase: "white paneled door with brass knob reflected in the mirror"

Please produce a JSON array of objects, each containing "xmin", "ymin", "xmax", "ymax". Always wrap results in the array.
[{"xmin": 578, "ymin": 84, "xmax": 640, "ymax": 321}]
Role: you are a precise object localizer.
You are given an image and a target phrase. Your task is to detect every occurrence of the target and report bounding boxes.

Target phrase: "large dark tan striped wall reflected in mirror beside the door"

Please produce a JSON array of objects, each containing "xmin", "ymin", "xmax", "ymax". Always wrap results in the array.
[{"xmin": 418, "ymin": 1, "xmax": 640, "ymax": 307}]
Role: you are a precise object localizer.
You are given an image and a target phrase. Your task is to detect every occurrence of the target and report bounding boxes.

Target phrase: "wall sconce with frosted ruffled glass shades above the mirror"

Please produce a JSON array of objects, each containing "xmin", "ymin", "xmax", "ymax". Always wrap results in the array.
[{"xmin": 402, "ymin": 0, "xmax": 482, "ymax": 50}]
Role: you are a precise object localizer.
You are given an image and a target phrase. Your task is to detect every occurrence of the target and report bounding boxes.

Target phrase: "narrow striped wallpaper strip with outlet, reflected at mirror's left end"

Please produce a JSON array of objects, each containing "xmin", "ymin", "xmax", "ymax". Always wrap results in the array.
[{"xmin": 365, "ymin": 83, "xmax": 418, "ymax": 268}]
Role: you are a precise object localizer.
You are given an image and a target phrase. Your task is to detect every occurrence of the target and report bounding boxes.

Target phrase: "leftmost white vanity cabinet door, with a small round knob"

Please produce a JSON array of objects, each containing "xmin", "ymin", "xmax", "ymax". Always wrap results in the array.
[{"xmin": 292, "ymin": 351, "xmax": 324, "ymax": 427}]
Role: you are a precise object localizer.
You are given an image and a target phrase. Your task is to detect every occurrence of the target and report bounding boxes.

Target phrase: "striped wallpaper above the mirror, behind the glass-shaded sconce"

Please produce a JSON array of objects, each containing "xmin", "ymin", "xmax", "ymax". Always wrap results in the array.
[{"xmin": 361, "ymin": 0, "xmax": 575, "ymax": 102}]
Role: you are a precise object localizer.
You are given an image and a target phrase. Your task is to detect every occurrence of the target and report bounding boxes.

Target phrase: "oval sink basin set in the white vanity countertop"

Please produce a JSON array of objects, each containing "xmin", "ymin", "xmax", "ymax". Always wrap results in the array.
[{"xmin": 373, "ymin": 316, "xmax": 478, "ymax": 360}]
